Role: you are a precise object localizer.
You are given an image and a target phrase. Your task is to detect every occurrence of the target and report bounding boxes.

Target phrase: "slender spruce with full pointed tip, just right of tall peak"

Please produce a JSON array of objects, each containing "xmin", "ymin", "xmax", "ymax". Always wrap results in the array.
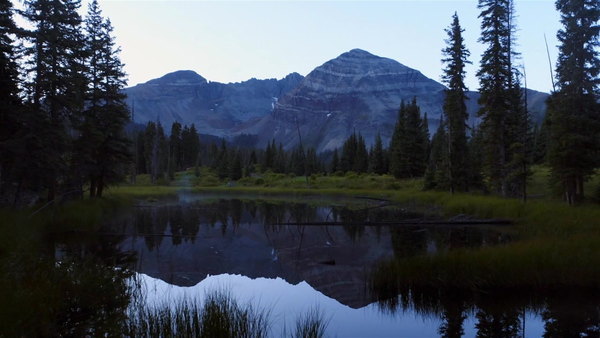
[{"xmin": 436, "ymin": 13, "xmax": 470, "ymax": 193}]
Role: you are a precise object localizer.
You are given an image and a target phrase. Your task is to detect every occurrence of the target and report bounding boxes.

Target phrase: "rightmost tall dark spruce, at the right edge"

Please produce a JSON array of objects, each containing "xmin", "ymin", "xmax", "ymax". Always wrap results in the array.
[{"xmin": 548, "ymin": 0, "xmax": 600, "ymax": 204}]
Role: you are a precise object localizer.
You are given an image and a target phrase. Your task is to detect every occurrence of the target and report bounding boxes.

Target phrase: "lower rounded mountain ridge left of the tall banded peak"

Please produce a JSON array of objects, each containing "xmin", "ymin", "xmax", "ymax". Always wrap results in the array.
[{"xmin": 125, "ymin": 70, "xmax": 303, "ymax": 136}]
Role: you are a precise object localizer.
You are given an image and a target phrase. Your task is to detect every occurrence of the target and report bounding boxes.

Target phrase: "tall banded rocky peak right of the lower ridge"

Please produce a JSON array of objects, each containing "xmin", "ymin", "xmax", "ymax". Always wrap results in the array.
[{"xmin": 245, "ymin": 49, "xmax": 444, "ymax": 151}]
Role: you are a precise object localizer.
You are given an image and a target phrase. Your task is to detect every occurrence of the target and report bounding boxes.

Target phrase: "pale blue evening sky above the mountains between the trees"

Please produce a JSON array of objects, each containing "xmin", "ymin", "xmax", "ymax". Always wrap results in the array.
[{"xmin": 100, "ymin": 0, "xmax": 560, "ymax": 91}]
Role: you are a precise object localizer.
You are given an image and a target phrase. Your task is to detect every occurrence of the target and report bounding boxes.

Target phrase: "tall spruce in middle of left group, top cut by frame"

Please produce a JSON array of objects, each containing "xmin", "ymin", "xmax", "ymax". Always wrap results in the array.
[{"xmin": 22, "ymin": 0, "xmax": 84, "ymax": 200}]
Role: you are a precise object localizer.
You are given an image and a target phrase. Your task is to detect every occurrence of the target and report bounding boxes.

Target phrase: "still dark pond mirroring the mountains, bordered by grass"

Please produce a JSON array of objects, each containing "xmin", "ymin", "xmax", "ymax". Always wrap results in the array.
[{"xmin": 0, "ymin": 194, "xmax": 600, "ymax": 337}]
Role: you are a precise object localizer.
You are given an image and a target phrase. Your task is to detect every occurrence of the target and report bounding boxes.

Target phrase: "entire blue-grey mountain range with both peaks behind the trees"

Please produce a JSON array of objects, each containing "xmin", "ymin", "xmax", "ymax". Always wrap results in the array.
[{"xmin": 126, "ymin": 49, "xmax": 548, "ymax": 151}]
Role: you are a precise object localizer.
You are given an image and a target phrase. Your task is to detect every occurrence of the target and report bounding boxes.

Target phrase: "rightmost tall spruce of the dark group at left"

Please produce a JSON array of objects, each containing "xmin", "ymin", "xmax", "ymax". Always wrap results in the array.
[{"xmin": 80, "ymin": 0, "xmax": 131, "ymax": 197}]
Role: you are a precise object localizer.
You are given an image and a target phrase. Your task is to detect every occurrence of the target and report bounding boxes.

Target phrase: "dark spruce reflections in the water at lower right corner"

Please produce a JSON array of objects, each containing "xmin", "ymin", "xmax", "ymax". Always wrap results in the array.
[{"xmin": 372, "ymin": 272, "xmax": 600, "ymax": 337}]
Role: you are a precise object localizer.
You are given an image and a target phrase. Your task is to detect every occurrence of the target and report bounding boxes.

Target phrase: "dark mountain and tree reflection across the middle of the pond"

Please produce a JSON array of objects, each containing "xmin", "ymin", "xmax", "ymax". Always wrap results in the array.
[{"xmin": 112, "ymin": 199, "xmax": 510, "ymax": 308}]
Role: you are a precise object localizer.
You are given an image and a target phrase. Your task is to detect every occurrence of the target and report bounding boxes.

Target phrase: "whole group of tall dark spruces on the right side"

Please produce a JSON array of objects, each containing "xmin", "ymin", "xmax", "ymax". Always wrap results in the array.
[{"xmin": 425, "ymin": 0, "xmax": 600, "ymax": 204}]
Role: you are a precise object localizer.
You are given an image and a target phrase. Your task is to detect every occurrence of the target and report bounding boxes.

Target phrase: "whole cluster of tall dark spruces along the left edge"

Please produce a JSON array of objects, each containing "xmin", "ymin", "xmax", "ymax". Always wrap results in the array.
[{"xmin": 0, "ymin": 0, "xmax": 130, "ymax": 205}]
